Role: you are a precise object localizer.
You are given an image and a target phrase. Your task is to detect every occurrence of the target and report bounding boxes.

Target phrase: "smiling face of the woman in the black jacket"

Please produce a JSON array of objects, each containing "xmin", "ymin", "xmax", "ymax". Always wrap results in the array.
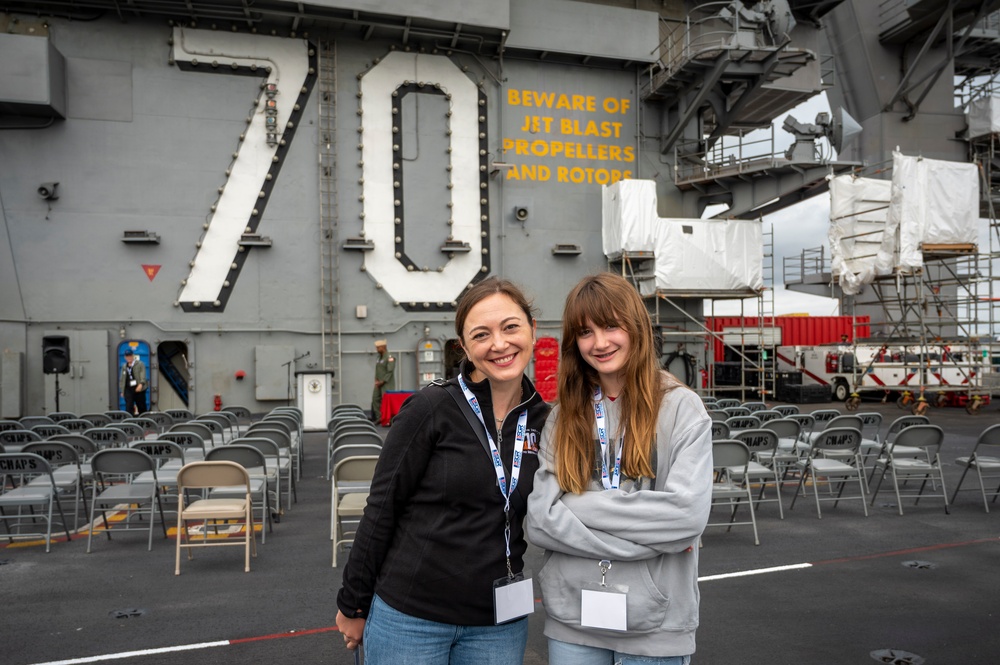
[{"xmin": 462, "ymin": 293, "xmax": 535, "ymax": 384}]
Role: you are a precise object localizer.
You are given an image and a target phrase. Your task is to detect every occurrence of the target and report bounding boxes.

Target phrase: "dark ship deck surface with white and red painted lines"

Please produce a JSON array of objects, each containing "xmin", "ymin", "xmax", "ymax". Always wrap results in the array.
[{"xmin": 0, "ymin": 396, "xmax": 1000, "ymax": 665}]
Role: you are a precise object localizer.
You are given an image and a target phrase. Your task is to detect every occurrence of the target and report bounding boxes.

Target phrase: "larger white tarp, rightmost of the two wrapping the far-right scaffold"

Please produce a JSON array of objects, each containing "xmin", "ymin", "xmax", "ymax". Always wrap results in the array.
[{"xmin": 876, "ymin": 151, "xmax": 979, "ymax": 272}]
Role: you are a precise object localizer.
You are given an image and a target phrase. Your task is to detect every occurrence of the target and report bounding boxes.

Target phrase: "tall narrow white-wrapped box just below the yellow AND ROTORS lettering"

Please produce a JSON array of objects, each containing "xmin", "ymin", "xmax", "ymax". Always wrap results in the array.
[{"xmin": 601, "ymin": 180, "xmax": 658, "ymax": 256}]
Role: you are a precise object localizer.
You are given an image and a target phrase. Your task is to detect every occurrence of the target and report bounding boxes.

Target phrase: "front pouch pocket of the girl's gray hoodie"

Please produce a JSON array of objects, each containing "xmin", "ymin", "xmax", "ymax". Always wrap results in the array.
[{"xmin": 536, "ymin": 552, "xmax": 670, "ymax": 634}]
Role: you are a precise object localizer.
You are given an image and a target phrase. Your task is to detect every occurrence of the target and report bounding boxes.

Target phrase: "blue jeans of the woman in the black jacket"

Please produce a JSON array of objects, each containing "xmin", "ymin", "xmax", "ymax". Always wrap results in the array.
[{"xmin": 364, "ymin": 596, "xmax": 528, "ymax": 665}]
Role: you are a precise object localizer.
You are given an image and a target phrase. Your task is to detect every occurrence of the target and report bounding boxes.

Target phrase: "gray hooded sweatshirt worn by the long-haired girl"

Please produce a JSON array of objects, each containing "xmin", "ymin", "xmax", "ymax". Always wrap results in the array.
[{"xmin": 525, "ymin": 377, "xmax": 712, "ymax": 657}]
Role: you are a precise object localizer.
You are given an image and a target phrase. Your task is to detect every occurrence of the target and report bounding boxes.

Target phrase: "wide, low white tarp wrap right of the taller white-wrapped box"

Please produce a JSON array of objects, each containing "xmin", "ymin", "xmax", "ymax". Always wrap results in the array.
[{"xmin": 654, "ymin": 219, "xmax": 764, "ymax": 293}]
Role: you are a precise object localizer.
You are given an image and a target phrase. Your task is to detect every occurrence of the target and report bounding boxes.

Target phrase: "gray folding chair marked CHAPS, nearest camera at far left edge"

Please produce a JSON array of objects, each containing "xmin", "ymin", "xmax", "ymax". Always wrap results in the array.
[{"xmin": 0, "ymin": 453, "xmax": 72, "ymax": 552}]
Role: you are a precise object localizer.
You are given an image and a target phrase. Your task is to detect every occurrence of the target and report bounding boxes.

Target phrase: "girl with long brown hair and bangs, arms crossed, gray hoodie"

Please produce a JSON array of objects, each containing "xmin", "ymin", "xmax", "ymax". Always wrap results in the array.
[{"xmin": 525, "ymin": 273, "xmax": 712, "ymax": 665}]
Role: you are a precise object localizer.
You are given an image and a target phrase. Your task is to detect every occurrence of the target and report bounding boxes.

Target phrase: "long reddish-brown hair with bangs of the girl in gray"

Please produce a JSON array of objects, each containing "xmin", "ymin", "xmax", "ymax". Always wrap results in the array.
[{"xmin": 553, "ymin": 272, "xmax": 672, "ymax": 494}]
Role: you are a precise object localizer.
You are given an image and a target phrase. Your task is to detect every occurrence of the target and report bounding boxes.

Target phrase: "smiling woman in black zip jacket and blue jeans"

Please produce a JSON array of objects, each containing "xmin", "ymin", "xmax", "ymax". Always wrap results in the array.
[{"xmin": 337, "ymin": 278, "xmax": 548, "ymax": 665}]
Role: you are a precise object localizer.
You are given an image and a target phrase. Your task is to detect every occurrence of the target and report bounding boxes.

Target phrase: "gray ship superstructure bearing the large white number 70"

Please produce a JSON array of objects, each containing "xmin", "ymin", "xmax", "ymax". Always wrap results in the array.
[{"xmin": 0, "ymin": 0, "xmax": 1000, "ymax": 417}]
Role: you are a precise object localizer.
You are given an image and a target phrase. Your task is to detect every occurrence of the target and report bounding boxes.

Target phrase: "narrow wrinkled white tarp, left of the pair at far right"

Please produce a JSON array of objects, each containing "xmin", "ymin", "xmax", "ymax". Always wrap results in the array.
[{"xmin": 829, "ymin": 175, "xmax": 892, "ymax": 295}]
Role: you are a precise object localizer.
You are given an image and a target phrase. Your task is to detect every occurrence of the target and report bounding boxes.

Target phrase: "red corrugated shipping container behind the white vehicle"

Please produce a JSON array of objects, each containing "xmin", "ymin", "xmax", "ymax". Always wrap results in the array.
[{"xmin": 705, "ymin": 316, "xmax": 871, "ymax": 361}]
